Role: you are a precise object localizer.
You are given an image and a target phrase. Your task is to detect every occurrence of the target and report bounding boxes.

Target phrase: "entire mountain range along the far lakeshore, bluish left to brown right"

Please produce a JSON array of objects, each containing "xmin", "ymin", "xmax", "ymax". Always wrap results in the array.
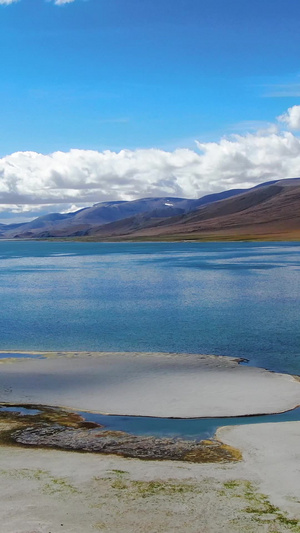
[{"xmin": 0, "ymin": 178, "xmax": 300, "ymax": 241}]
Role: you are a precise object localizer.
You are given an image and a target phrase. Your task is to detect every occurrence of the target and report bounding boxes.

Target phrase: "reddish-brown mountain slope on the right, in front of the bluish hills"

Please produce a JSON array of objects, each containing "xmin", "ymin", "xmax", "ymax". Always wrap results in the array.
[{"xmin": 86, "ymin": 179, "xmax": 300, "ymax": 240}]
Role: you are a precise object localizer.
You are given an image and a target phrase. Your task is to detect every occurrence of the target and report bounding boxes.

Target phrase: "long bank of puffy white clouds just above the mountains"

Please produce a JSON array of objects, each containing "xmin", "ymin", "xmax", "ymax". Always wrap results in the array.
[{"xmin": 0, "ymin": 122, "xmax": 300, "ymax": 218}]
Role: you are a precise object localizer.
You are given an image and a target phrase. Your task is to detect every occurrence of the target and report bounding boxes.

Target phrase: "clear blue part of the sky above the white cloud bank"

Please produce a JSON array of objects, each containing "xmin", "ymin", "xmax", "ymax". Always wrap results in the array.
[{"xmin": 0, "ymin": 0, "xmax": 300, "ymax": 220}]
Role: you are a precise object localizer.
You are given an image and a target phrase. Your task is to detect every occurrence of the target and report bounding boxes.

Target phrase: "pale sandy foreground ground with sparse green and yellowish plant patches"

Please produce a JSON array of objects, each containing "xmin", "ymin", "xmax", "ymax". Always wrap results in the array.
[{"xmin": 0, "ymin": 422, "xmax": 300, "ymax": 533}]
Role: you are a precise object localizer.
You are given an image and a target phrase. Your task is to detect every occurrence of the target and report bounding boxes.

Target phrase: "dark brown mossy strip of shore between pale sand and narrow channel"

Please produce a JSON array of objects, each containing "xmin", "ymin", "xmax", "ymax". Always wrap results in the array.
[{"xmin": 0, "ymin": 404, "xmax": 241, "ymax": 463}]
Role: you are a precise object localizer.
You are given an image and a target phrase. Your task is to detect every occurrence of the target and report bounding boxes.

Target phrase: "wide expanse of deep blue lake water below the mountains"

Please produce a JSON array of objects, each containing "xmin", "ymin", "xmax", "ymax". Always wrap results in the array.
[{"xmin": 0, "ymin": 241, "xmax": 300, "ymax": 374}]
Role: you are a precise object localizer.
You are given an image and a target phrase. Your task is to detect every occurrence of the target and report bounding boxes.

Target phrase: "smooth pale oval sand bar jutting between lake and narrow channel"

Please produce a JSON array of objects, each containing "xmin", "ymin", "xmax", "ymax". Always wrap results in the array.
[{"xmin": 0, "ymin": 353, "xmax": 300, "ymax": 418}]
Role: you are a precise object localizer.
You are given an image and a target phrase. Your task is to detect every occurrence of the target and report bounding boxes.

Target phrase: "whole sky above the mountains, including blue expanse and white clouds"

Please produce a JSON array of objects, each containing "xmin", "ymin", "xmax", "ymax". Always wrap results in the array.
[{"xmin": 0, "ymin": 0, "xmax": 300, "ymax": 223}]
